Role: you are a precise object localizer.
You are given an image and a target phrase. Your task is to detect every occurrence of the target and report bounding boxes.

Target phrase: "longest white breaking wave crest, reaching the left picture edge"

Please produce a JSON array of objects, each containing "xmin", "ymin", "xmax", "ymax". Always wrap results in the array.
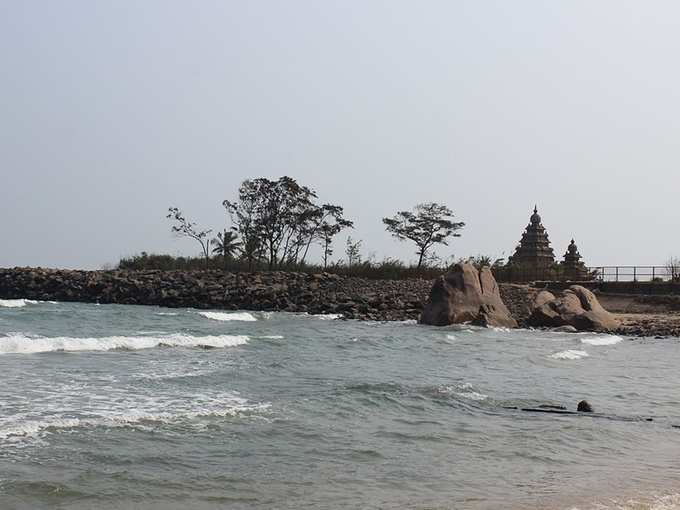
[{"xmin": 0, "ymin": 334, "xmax": 248, "ymax": 354}]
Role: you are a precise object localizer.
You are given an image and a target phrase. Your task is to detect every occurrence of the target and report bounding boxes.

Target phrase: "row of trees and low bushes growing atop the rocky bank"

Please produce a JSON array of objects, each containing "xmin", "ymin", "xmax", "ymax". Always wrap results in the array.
[{"xmin": 118, "ymin": 176, "xmax": 472, "ymax": 279}]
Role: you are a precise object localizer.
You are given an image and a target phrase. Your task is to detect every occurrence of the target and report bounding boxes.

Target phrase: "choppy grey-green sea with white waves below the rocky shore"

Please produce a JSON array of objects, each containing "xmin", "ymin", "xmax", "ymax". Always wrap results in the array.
[{"xmin": 0, "ymin": 300, "xmax": 680, "ymax": 510}]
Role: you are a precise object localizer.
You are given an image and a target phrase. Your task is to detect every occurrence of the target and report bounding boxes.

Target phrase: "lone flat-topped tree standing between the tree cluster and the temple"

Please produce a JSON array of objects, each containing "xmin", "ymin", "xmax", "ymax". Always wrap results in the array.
[{"xmin": 383, "ymin": 202, "xmax": 465, "ymax": 268}]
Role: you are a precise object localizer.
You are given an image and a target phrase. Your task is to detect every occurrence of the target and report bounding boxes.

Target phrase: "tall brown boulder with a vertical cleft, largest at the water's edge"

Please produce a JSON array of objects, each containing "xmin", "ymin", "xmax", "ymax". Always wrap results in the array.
[{"xmin": 420, "ymin": 264, "xmax": 517, "ymax": 328}]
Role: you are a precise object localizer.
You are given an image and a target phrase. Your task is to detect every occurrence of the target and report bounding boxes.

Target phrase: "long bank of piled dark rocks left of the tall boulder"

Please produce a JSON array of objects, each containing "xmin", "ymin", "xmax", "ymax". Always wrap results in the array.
[{"xmin": 0, "ymin": 268, "xmax": 431, "ymax": 320}]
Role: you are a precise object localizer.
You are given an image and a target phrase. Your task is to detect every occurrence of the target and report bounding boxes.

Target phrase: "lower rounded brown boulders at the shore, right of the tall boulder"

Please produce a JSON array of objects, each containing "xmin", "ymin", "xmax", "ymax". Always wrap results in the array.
[{"xmin": 528, "ymin": 285, "xmax": 621, "ymax": 331}]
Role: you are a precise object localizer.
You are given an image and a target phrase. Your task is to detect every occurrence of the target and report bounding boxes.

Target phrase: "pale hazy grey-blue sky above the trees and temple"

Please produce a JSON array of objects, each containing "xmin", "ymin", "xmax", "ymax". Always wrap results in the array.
[{"xmin": 0, "ymin": 0, "xmax": 680, "ymax": 268}]
